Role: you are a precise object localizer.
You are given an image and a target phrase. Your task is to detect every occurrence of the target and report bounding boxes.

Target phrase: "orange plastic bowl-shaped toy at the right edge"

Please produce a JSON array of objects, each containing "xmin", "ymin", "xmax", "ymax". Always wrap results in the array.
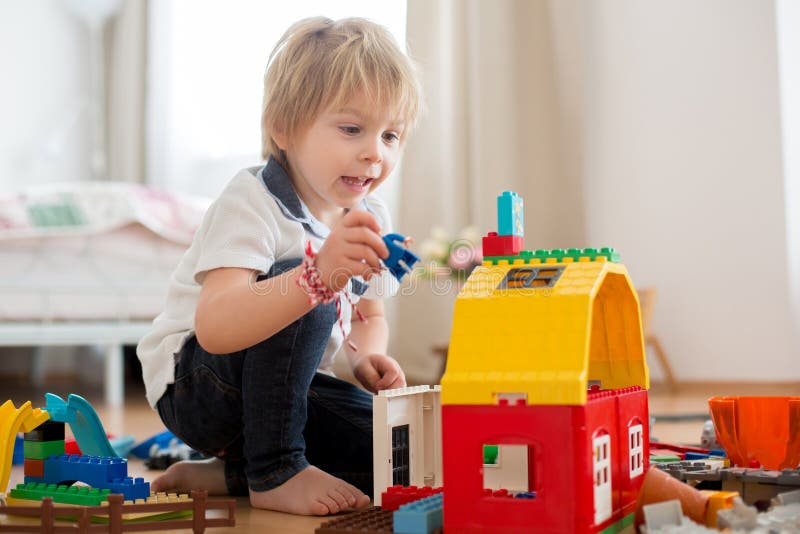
[{"xmin": 708, "ymin": 397, "xmax": 800, "ymax": 469}]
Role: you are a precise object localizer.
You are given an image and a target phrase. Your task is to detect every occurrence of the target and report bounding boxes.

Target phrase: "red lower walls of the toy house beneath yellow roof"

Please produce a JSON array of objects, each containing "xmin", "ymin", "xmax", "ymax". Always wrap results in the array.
[{"xmin": 442, "ymin": 388, "xmax": 649, "ymax": 534}]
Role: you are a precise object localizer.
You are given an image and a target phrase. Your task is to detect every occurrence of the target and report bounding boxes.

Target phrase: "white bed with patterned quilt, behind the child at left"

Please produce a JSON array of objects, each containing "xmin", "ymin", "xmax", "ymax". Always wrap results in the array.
[{"xmin": 0, "ymin": 182, "xmax": 209, "ymax": 405}]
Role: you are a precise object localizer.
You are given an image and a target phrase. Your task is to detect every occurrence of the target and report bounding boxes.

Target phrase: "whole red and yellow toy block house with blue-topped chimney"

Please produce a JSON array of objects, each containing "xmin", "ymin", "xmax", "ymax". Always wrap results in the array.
[{"xmin": 441, "ymin": 193, "xmax": 649, "ymax": 533}]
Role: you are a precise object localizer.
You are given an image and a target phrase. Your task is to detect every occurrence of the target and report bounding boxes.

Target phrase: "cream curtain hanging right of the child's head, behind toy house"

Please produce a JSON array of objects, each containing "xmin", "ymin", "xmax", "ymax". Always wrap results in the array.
[{"xmin": 392, "ymin": 0, "xmax": 585, "ymax": 383}]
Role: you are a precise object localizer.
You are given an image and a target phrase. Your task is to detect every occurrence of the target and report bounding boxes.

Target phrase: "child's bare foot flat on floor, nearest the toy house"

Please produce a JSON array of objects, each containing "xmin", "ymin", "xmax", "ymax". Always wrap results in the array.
[{"xmin": 250, "ymin": 464, "xmax": 369, "ymax": 515}]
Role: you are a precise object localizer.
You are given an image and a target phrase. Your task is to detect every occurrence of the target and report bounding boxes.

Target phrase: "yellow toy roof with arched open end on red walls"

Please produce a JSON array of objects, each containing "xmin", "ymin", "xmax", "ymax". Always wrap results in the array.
[{"xmin": 442, "ymin": 257, "xmax": 650, "ymax": 405}]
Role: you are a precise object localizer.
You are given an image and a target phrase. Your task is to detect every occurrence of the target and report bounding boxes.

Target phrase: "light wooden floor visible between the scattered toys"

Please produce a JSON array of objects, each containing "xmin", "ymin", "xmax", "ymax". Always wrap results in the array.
[{"xmin": 0, "ymin": 382, "xmax": 800, "ymax": 534}]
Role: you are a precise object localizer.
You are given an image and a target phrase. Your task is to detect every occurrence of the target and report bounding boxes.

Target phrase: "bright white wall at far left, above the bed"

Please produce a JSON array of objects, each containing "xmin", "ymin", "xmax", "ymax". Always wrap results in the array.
[{"xmin": 0, "ymin": 0, "xmax": 89, "ymax": 192}]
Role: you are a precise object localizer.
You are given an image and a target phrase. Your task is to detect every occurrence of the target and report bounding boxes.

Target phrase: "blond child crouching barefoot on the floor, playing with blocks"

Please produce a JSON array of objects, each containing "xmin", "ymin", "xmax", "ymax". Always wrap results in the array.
[{"xmin": 138, "ymin": 18, "xmax": 420, "ymax": 515}]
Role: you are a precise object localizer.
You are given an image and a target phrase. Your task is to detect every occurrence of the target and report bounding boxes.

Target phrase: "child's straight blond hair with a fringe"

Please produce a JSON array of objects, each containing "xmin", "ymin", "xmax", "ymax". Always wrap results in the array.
[{"xmin": 261, "ymin": 17, "xmax": 421, "ymax": 164}]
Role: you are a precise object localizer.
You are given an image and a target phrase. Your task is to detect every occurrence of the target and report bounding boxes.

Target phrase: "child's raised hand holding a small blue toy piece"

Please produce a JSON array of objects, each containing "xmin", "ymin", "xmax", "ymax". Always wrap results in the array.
[{"xmin": 317, "ymin": 210, "xmax": 389, "ymax": 292}]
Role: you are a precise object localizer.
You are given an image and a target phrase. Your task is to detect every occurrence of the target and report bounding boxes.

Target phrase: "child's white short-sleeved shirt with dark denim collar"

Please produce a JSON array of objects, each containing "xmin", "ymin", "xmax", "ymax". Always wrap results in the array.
[{"xmin": 137, "ymin": 159, "xmax": 399, "ymax": 407}]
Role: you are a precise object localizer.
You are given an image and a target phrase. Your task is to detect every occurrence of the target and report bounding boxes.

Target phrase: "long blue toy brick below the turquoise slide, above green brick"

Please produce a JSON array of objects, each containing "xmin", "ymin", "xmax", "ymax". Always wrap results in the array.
[{"xmin": 44, "ymin": 454, "xmax": 128, "ymax": 488}]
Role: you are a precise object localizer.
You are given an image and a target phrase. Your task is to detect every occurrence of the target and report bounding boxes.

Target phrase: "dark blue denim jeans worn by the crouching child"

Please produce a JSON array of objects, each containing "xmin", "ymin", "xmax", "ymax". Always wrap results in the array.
[{"xmin": 157, "ymin": 260, "xmax": 372, "ymax": 495}]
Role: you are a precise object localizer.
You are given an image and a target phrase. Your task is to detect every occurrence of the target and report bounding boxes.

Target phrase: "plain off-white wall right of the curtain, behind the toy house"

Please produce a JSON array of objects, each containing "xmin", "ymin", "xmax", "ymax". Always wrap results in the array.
[{"xmin": 584, "ymin": 0, "xmax": 800, "ymax": 381}]
